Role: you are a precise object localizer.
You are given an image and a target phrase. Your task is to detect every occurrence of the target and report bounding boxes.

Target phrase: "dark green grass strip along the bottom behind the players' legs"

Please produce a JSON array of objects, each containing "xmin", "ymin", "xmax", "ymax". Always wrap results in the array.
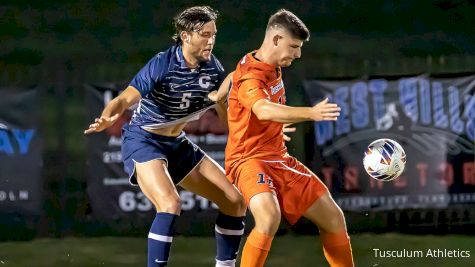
[{"xmin": 0, "ymin": 234, "xmax": 475, "ymax": 267}]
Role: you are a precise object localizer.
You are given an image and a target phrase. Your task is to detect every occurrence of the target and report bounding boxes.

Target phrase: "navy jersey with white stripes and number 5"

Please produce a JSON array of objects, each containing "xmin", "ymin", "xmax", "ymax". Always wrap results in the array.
[{"xmin": 130, "ymin": 46, "xmax": 226, "ymax": 129}]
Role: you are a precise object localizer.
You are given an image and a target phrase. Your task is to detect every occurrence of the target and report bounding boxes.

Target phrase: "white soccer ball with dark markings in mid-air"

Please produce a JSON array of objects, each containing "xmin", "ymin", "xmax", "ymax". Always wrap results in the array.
[{"xmin": 363, "ymin": 139, "xmax": 406, "ymax": 181}]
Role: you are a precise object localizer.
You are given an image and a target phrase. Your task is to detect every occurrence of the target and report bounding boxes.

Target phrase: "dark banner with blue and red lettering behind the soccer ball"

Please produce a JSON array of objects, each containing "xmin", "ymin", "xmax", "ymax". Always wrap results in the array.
[{"xmin": 304, "ymin": 75, "xmax": 475, "ymax": 211}]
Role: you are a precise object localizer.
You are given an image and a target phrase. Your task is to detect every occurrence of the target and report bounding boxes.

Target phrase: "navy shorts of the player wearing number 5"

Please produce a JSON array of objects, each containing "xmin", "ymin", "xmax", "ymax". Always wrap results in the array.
[{"xmin": 122, "ymin": 124, "xmax": 205, "ymax": 185}]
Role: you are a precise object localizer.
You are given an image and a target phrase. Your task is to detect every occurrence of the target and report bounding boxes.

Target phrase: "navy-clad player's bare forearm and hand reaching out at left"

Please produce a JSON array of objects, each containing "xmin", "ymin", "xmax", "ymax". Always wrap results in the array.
[{"xmin": 84, "ymin": 86, "xmax": 141, "ymax": 134}]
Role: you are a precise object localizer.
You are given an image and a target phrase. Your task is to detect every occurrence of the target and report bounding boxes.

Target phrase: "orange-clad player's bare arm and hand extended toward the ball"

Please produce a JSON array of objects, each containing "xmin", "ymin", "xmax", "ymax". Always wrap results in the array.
[{"xmin": 252, "ymin": 98, "xmax": 340, "ymax": 123}]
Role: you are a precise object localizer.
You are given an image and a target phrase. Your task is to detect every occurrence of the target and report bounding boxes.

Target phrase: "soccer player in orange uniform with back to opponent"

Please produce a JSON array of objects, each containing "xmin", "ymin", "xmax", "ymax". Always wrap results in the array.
[{"xmin": 226, "ymin": 9, "xmax": 354, "ymax": 267}]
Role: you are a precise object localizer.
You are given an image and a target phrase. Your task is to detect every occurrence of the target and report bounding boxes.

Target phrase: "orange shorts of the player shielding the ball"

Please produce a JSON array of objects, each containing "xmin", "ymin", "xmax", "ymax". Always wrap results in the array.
[{"xmin": 228, "ymin": 156, "xmax": 328, "ymax": 224}]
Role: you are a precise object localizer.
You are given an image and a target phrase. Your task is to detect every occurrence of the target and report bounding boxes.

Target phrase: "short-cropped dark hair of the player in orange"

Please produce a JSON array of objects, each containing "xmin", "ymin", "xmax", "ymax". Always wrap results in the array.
[{"xmin": 267, "ymin": 9, "xmax": 310, "ymax": 41}]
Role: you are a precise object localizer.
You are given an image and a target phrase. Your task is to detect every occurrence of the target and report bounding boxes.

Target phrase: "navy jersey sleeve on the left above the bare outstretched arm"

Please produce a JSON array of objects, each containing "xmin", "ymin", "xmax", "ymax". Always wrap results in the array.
[{"xmin": 129, "ymin": 53, "xmax": 166, "ymax": 96}]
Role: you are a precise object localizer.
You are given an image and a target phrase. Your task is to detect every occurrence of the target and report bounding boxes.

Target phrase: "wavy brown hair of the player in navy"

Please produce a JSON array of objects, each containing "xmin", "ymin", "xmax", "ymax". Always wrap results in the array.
[{"xmin": 173, "ymin": 6, "xmax": 218, "ymax": 45}]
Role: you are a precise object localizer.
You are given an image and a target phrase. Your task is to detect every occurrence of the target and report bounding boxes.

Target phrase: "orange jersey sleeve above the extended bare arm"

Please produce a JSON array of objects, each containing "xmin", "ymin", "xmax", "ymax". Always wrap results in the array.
[{"xmin": 238, "ymin": 79, "xmax": 270, "ymax": 110}]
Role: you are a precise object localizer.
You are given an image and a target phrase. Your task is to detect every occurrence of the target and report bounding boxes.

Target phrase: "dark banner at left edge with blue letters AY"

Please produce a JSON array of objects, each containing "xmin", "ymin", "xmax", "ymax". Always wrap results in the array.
[{"xmin": 0, "ymin": 88, "xmax": 43, "ymax": 217}]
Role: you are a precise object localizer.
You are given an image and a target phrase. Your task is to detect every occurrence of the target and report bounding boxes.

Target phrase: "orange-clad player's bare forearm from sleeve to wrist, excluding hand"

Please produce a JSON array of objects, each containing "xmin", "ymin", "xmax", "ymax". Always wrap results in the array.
[{"xmin": 252, "ymin": 102, "xmax": 312, "ymax": 123}]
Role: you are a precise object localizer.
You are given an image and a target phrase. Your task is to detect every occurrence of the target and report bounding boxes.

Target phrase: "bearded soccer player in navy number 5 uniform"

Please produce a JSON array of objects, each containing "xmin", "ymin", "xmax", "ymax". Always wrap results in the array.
[{"xmin": 85, "ymin": 6, "xmax": 246, "ymax": 267}]
